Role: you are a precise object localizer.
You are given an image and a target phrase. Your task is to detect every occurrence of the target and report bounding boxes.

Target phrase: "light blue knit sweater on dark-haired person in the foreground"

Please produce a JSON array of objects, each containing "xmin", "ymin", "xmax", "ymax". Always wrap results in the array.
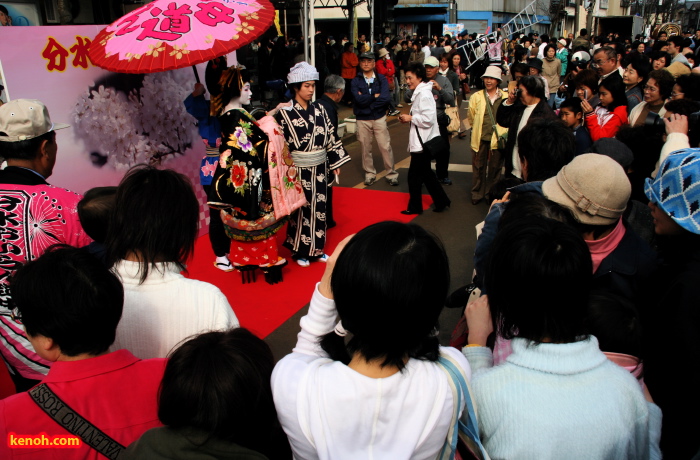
[{"xmin": 463, "ymin": 336, "xmax": 661, "ymax": 460}]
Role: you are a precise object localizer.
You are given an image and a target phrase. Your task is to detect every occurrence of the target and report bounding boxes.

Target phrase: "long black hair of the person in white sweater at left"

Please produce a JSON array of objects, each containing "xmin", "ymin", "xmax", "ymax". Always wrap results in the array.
[{"xmin": 105, "ymin": 165, "xmax": 199, "ymax": 283}]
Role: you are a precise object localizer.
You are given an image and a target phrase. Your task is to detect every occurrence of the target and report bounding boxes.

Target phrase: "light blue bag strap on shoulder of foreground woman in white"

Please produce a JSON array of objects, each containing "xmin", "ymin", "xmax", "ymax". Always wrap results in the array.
[{"xmin": 437, "ymin": 354, "xmax": 490, "ymax": 460}]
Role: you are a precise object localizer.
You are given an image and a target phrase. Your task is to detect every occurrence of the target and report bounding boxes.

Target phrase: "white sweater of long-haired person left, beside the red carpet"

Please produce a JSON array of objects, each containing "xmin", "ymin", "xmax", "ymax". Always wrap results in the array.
[{"xmin": 110, "ymin": 260, "xmax": 239, "ymax": 359}]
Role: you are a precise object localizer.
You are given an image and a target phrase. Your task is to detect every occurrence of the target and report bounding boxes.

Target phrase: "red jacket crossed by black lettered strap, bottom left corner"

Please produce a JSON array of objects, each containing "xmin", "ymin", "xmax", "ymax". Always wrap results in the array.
[{"xmin": 0, "ymin": 350, "xmax": 167, "ymax": 460}]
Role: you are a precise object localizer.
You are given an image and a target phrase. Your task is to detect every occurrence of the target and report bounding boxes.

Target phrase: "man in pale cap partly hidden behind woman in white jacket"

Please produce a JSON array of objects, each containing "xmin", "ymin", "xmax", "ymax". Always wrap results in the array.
[{"xmin": 405, "ymin": 56, "xmax": 455, "ymax": 185}]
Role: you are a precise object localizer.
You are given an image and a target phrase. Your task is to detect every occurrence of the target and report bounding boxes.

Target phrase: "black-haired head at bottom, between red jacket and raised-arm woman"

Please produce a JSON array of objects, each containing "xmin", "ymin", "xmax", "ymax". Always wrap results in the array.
[{"xmin": 158, "ymin": 328, "xmax": 277, "ymax": 451}]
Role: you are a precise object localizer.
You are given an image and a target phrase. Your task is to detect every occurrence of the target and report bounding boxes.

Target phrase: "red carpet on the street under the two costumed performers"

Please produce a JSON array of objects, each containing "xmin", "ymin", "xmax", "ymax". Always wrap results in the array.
[{"xmin": 183, "ymin": 187, "xmax": 432, "ymax": 338}]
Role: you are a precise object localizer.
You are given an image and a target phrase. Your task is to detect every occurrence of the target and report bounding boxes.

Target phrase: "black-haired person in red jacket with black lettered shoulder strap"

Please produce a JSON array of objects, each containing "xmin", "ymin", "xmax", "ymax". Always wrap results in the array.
[{"xmin": 0, "ymin": 246, "xmax": 165, "ymax": 460}]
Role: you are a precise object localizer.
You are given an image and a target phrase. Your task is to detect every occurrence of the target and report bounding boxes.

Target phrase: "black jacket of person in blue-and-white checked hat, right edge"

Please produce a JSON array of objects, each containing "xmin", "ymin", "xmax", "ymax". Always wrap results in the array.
[{"xmin": 642, "ymin": 243, "xmax": 700, "ymax": 459}]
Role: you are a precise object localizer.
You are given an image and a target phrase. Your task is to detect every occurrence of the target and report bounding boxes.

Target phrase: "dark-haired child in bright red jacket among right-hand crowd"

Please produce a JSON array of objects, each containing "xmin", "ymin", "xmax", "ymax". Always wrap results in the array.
[{"xmin": 581, "ymin": 75, "xmax": 628, "ymax": 142}]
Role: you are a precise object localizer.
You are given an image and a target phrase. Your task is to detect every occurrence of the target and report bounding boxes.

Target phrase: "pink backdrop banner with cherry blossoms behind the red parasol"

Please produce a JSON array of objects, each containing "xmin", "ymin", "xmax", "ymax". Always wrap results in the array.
[{"xmin": 0, "ymin": 25, "xmax": 235, "ymax": 233}]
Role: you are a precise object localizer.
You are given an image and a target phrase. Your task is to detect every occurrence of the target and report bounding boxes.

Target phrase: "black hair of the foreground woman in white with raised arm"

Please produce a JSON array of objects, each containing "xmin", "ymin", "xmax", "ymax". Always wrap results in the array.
[{"xmin": 321, "ymin": 221, "xmax": 450, "ymax": 370}]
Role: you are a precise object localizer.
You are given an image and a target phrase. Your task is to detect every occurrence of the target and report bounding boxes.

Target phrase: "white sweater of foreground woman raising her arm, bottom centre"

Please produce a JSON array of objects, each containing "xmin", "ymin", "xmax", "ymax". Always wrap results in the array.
[{"xmin": 272, "ymin": 286, "xmax": 471, "ymax": 460}]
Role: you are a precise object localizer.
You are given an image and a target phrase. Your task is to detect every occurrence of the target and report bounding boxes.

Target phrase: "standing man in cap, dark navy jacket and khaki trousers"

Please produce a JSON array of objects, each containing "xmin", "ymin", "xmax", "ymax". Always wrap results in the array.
[{"xmin": 350, "ymin": 53, "xmax": 399, "ymax": 187}]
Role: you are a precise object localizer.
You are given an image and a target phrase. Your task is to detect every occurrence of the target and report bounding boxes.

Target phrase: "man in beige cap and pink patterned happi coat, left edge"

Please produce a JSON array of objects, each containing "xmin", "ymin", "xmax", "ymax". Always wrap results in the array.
[{"xmin": 0, "ymin": 99, "xmax": 90, "ymax": 391}]
